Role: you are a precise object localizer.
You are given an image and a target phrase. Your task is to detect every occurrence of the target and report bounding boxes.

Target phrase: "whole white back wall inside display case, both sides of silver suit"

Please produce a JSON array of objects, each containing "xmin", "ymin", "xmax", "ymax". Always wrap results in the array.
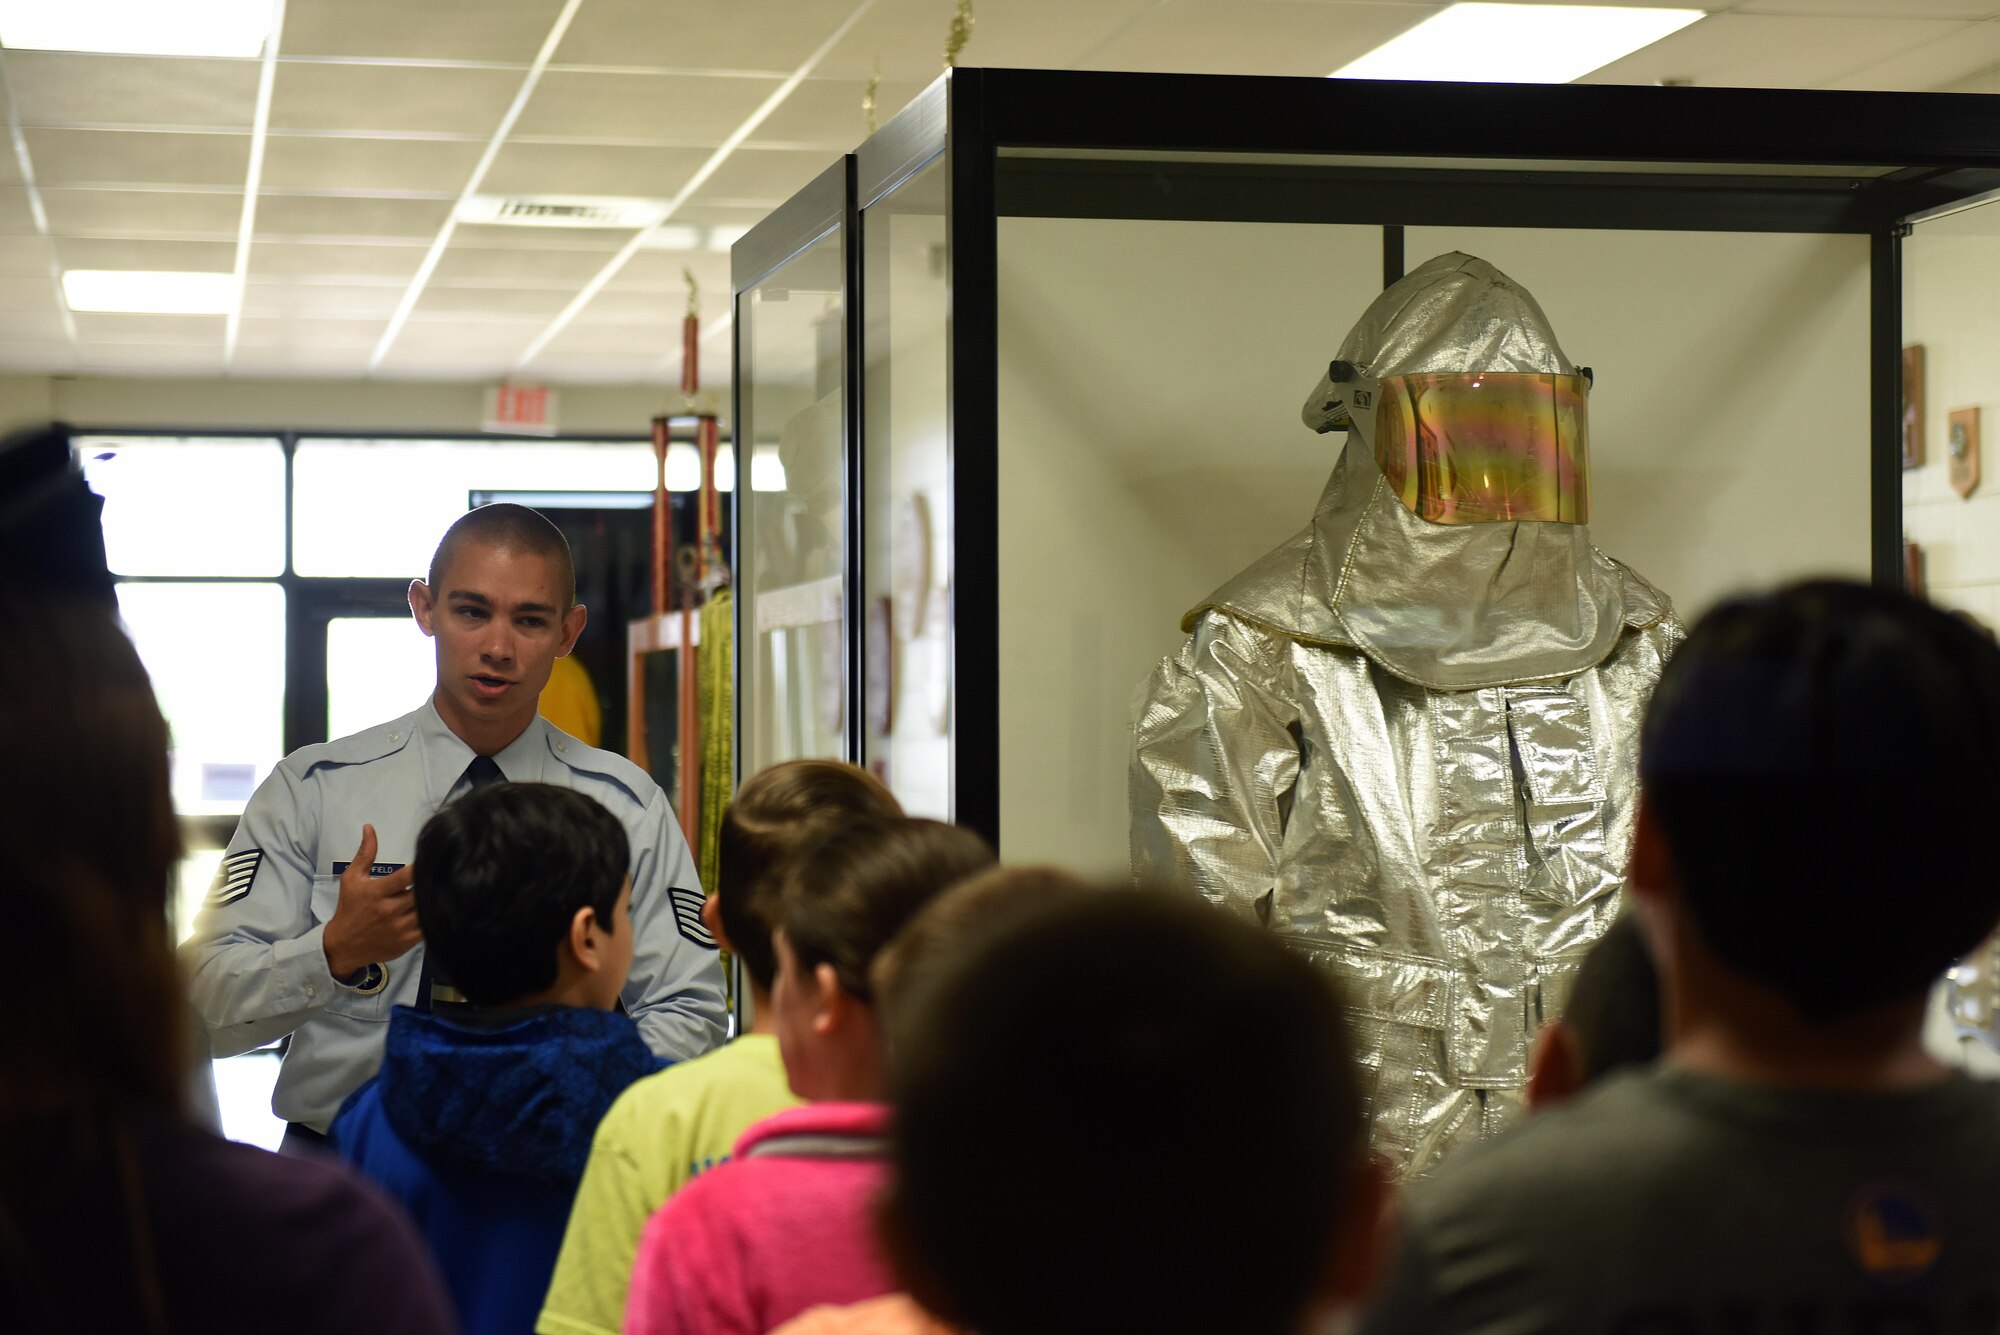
[{"xmin": 1000, "ymin": 218, "xmax": 1868, "ymax": 873}]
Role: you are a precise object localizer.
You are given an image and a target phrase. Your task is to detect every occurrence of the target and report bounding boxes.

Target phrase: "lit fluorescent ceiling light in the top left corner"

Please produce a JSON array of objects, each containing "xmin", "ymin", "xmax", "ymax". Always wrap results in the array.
[{"xmin": 0, "ymin": 0, "xmax": 274, "ymax": 58}]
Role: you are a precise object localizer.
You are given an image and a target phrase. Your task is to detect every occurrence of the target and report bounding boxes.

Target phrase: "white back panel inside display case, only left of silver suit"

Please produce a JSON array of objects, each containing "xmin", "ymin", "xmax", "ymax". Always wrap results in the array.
[{"xmin": 1000, "ymin": 218, "xmax": 1382, "ymax": 875}]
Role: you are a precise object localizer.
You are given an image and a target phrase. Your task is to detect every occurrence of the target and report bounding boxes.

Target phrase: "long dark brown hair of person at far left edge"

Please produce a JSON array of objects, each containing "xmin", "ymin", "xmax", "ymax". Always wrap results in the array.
[{"xmin": 0, "ymin": 586, "xmax": 188, "ymax": 1331}]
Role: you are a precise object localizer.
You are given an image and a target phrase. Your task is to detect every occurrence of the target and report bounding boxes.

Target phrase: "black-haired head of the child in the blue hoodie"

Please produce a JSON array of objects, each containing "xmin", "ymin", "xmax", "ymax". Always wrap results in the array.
[{"xmin": 414, "ymin": 783, "xmax": 632, "ymax": 1009}]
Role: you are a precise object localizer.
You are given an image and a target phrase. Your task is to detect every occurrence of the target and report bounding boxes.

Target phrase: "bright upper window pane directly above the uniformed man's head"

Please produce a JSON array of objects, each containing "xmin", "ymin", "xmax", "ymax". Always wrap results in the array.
[{"xmin": 292, "ymin": 438, "xmax": 656, "ymax": 580}]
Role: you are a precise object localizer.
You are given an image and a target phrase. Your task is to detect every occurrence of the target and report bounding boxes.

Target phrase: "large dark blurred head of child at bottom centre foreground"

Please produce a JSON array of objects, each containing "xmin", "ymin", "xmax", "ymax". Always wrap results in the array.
[{"xmin": 878, "ymin": 887, "xmax": 1368, "ymax": 1335}]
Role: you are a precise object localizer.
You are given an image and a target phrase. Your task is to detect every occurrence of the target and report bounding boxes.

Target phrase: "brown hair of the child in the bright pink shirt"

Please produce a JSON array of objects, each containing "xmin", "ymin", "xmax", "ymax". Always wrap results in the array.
[{"xmin": 776, "ymin": 819, "xmax": 994, "ymax": 1001}]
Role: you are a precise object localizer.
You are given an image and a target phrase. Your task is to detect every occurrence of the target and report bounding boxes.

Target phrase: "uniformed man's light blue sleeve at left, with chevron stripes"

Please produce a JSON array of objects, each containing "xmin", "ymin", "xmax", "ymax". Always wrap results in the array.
[{"xmin": 180, "ymin": 765, "xmax": 336, "ymax": 1057}]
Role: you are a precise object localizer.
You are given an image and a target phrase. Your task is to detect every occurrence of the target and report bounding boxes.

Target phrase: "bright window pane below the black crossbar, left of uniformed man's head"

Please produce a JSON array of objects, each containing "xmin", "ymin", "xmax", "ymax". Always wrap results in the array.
[{"xmin": 118, "ymin": 584, "xmax": 284, "ymax": 823}]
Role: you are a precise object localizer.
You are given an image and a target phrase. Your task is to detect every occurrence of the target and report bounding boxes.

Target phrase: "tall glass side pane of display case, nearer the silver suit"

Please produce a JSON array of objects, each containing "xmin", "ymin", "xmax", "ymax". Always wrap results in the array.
[{"xmin": 862, "ymin": 160, "xmax": 952, "ymax": 819}]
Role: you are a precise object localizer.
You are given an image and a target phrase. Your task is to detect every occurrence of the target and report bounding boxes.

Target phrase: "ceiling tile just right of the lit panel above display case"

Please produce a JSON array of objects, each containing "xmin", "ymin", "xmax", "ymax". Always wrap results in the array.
[{"xmin": 1578, "ymin": 14, "xmax": 1964, "ymax": 88}]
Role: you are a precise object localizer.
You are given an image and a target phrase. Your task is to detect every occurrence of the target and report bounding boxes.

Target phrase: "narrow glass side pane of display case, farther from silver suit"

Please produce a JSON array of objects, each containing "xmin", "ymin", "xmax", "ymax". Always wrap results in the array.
[{"xmin": 744, "ymin": 228, "xmax": 848, "ymax": 773}]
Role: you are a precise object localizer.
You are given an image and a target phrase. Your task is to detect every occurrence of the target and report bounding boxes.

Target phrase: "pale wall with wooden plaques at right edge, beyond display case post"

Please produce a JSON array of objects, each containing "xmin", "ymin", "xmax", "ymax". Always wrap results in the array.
[{"xmin": 1902, "ymin": 206, "xmax": 2000, "ymax": 626}]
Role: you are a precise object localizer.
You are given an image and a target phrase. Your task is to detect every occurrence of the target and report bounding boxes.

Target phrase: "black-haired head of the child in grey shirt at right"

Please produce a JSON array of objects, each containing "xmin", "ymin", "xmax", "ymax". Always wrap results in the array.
[{"xmin": 1640, "ymin": 582, "xmax": 2000, "ymax": 1021}]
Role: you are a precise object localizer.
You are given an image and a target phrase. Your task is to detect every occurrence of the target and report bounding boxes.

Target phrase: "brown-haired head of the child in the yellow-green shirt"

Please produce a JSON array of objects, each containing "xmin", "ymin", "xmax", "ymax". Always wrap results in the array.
[{"xmin": 702, "ymin": 759, "xmax": 902, "ymax": 993}]
